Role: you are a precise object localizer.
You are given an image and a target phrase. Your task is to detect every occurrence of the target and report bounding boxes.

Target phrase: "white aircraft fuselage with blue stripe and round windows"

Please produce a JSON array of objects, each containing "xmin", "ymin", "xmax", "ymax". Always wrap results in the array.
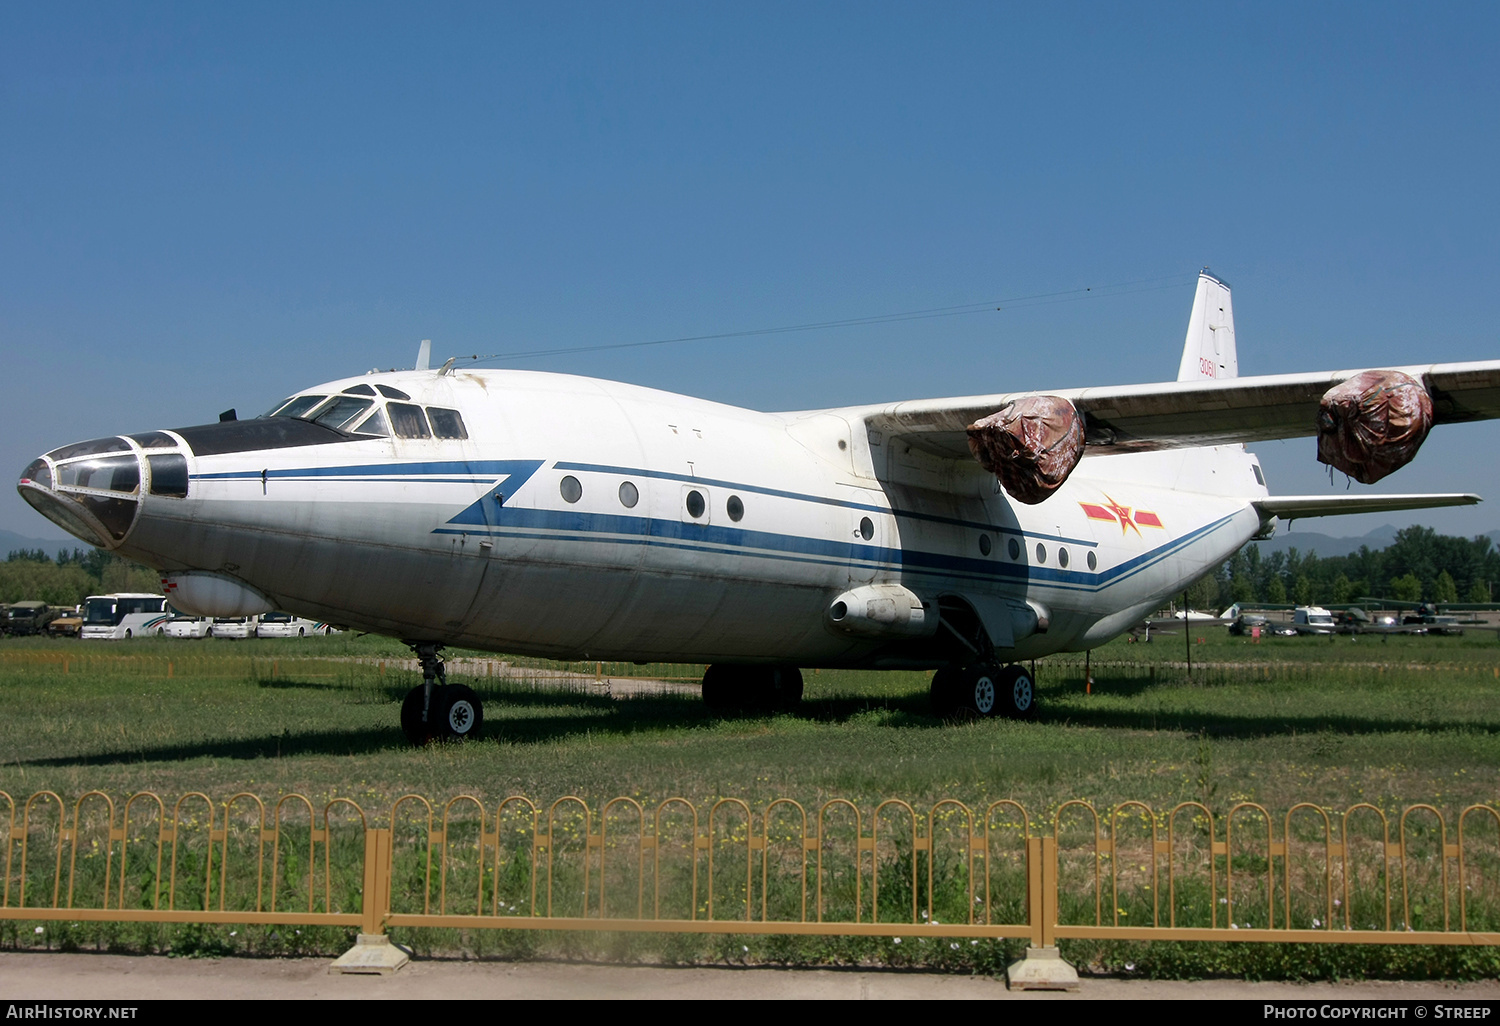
[{"xmin": 23, "ymin": 371, "xmax": 1266, "ymax": 668}]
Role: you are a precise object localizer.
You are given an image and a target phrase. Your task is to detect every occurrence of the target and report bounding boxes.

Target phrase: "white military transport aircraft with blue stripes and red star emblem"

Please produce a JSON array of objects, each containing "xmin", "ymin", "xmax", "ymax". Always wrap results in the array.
[{"xmin": 18, "ymin": 273, "xmax": 1500, "ymax": 744}]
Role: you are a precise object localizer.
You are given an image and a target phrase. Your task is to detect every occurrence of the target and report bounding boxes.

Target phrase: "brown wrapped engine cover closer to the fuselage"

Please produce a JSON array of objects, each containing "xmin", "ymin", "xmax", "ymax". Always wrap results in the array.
[{"xmin": 969, "ymin": 396, "xmax": 1083, "ymax": 506}]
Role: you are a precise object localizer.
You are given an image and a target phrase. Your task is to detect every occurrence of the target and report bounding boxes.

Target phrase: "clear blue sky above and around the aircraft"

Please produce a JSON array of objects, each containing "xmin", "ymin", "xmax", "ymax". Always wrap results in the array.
[{"xmin": 0, "ymin": 3, "xmax": 1500, "ymax": 537}]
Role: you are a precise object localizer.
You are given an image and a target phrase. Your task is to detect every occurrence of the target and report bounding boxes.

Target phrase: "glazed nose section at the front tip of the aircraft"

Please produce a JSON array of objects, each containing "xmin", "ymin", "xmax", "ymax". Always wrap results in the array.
[{"xmin": 17, "ymin": 437, "xmax": 150, "ymax": 549}]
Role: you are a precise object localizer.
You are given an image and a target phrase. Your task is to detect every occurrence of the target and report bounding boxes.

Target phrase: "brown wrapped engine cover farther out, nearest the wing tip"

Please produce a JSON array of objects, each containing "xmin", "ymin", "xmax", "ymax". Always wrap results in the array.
[{"xmin": 1317, "ymin": 371, "xmax": 1433, "ymax": 485}]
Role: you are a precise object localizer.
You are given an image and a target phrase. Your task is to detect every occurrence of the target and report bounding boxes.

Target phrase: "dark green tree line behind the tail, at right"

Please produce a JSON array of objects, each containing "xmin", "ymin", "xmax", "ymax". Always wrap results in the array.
[{"xmin": 1188, "ymin": 527, "xmax": 1500, "ymax": 609}]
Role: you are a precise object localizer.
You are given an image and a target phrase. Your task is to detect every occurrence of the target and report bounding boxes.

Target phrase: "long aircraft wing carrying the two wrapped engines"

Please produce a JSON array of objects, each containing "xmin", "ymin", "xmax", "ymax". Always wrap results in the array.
[{"xmin": 842, "ymin": 360, "xmax": 1500, "ymax": 456}]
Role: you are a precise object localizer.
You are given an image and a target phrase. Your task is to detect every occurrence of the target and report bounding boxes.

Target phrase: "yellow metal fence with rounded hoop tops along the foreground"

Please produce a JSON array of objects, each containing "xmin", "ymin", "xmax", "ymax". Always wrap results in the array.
[{"xmin": 0, "ymin": 791, "xmax": 1500, "ymax": 945}]
